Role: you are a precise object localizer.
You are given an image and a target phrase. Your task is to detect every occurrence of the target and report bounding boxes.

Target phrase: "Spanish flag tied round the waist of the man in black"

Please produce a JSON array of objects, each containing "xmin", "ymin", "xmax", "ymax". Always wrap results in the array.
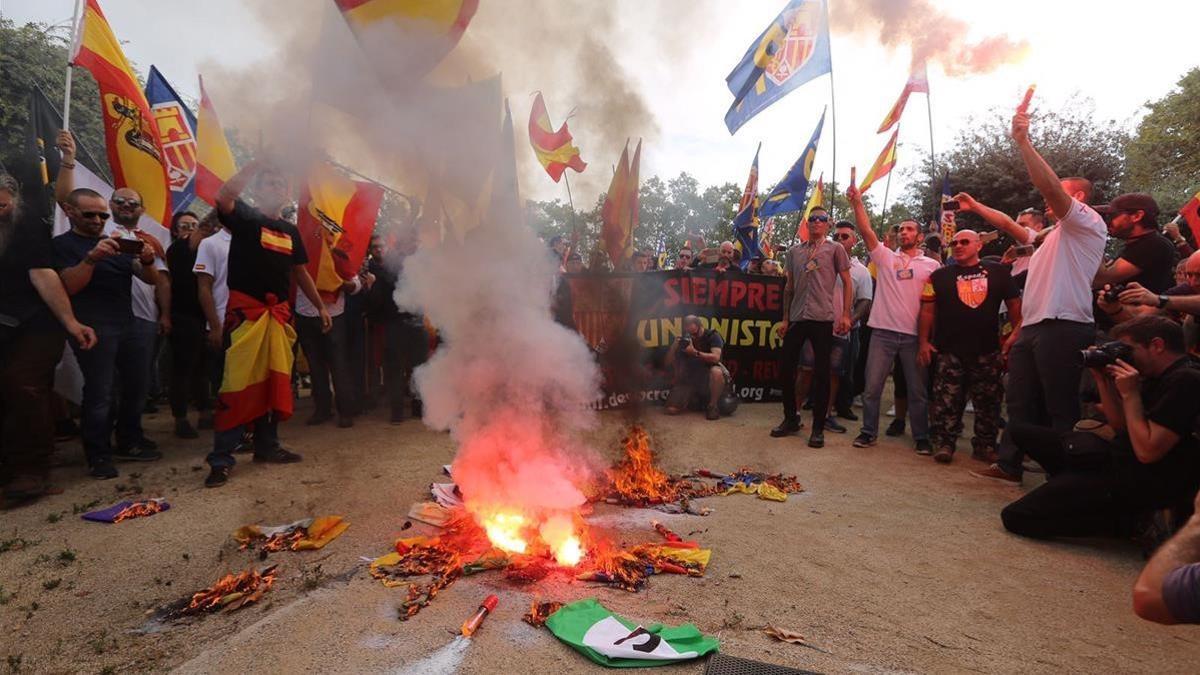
[{"xmin": 214, "ymin": 290, "xmax": 296, "ymax": 431}]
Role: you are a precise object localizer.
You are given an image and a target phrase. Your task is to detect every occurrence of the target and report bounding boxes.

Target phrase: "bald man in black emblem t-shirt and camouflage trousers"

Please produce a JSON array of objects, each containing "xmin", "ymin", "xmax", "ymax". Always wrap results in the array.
[{"xmin": 917, "ymin": 229, "xmax": 1021, "ymax": 464}]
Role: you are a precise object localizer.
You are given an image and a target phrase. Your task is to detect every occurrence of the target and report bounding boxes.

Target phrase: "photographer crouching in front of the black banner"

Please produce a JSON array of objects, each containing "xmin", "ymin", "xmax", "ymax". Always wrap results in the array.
[{"xmin": 666, "ymin": 315, "xmax": 736, "ymax": 419}]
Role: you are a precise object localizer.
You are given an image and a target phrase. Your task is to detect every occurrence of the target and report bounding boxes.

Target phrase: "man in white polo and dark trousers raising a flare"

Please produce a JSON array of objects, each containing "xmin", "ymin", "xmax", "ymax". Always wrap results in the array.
[{"xmin": 971, "ymin": 112, "xmax": 1108, "ymax": 485}]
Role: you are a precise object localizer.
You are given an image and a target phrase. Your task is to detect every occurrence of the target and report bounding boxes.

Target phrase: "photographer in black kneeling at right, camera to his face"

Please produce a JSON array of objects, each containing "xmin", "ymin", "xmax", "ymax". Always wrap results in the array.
[{"xmin": 1001, "ymin": 316, "xmax": 1200, "ymax": 538}]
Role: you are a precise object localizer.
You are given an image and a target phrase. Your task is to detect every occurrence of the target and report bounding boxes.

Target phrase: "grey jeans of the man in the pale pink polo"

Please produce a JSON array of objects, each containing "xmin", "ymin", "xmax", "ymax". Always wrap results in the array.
[{"xmin": 863, "ymin": 329, "xmax": 929, "ymax": 441}]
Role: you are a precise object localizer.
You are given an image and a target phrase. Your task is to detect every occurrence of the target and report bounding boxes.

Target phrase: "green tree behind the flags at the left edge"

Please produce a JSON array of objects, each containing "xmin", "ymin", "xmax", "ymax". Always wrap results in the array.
[{"xmin": 0, "ymin": 18, "xmax": 112, "ymax": 175}]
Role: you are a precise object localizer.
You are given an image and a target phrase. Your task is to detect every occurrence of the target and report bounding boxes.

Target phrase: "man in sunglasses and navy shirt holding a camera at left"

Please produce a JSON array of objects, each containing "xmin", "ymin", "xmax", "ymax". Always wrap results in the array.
[{"xmin": 53, "ymin": 187, "xmax": 162, "ymax": 479}]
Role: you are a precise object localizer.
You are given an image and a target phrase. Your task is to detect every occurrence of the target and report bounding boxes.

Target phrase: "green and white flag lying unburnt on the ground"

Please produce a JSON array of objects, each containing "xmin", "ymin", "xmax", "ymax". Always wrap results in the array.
[{"xmin": 546, "ymin": 598, "xmax": 719, "ymax": 668}]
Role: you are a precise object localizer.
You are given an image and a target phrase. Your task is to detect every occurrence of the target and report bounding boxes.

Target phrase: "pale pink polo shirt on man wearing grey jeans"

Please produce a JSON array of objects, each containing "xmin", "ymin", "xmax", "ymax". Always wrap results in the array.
[{"xmin": 866, "ymin": 244, "xmax": 941, "ymax": 335}]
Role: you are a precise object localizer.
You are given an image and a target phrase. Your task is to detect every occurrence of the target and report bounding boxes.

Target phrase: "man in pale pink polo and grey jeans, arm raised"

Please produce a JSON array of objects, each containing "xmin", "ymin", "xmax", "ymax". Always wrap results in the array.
[{"xmin": 846, "ymin": 179, "xmax": 941, "ymax": 455}]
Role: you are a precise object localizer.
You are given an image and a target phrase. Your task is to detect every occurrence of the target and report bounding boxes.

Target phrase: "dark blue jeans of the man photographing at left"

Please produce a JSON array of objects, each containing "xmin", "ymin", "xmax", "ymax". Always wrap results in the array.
[{"xmin": 71, "ymin": 318, "xmax": 158, "ymax": 464}]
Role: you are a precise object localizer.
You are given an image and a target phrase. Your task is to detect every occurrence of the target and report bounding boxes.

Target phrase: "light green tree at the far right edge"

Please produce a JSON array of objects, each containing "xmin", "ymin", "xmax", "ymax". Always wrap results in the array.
[{"xmin": 1122, "ymin": 67, "xmax": 1200, "ymax": 214}]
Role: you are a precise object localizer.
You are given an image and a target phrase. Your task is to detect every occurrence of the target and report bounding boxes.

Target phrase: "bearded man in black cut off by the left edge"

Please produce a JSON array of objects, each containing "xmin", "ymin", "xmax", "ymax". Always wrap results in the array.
[{"xmin": 0, "ymin": 174, "xmax": 96, "ymax": 499}]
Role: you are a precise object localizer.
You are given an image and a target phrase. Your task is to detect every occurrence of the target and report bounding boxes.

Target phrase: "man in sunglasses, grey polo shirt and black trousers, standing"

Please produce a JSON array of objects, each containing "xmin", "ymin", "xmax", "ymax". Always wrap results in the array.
[{"xmin": 770, "ymin": 207, "xmax": 853, "ymax": 448}]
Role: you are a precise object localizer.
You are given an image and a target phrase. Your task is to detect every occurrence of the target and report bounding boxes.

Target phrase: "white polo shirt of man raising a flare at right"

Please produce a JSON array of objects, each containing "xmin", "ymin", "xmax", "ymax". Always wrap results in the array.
[{"xmin": 1021, "ymin": 199, "xmax": 1109, "ymax": 325}]
